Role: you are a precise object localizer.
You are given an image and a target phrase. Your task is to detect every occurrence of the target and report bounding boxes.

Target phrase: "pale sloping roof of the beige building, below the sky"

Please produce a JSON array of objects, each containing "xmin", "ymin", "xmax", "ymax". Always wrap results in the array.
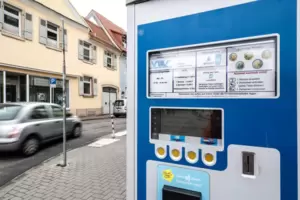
[{"xmin": 34, "ymin": 0, "xmax": 87, "ymax": 27}]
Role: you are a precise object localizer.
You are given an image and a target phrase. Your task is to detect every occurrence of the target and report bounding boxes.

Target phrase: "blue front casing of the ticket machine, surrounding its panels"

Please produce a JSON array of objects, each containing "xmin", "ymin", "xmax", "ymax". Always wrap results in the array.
[{"xmin": 136, "ymin": 0, "xmax": 298, "ymax": 200}]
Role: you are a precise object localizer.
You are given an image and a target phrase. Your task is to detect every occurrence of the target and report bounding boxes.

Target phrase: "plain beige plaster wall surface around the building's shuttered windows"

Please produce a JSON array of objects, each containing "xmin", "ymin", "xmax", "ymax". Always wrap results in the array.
[{"xmin": 0, "ymin": 0, "xmax": 120, "ymax": 114}]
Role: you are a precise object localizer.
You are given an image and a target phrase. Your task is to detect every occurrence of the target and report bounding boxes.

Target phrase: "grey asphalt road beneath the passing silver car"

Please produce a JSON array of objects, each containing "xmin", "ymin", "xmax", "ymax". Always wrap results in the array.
[{"xmin": 0, "ymin": 118, "xmax": 126, "ymax": 187}]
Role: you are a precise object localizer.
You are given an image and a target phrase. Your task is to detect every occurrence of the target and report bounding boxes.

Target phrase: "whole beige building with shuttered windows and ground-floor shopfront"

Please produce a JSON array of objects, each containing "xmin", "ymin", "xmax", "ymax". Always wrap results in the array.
[{"xmin": 0, "ymin": 0, "xmax": 122, "ymax": 116}]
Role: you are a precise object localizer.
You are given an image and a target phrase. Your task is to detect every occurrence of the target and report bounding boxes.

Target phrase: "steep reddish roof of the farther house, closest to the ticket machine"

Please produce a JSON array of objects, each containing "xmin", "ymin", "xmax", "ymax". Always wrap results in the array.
[{"xmin": 92, "ymin": 10, "xmax": 126, "ymax": 51}]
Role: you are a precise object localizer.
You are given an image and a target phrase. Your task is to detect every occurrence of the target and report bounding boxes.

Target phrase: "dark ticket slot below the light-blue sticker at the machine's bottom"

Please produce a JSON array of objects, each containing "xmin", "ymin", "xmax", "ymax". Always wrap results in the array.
[{"xmin": 162, "ymin": 185, "xmax": 202, "ymax": 200}]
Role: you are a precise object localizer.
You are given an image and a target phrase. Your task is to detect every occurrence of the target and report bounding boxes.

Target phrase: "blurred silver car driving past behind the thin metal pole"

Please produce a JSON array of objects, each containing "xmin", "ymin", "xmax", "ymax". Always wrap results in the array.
[{"xmin": 0, "ymin": 103, "xmax": 82, "ymax": 156}]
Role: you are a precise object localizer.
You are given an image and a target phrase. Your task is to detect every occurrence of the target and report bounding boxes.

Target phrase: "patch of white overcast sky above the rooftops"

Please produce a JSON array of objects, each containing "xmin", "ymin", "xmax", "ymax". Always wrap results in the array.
[{"xmin": 70, "ymin": 0, "xmax": 127, "ymax": 30}]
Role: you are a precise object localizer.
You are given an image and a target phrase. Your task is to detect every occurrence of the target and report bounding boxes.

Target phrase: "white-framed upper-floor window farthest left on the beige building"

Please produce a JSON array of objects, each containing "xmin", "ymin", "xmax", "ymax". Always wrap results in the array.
[{"xmin": 3, "ymin": 4, "xmax": 21, "ymax": 36}]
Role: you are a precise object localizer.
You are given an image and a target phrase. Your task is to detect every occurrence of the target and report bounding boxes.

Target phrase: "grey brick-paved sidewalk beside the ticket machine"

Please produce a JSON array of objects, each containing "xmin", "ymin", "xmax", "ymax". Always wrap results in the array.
[{"xmin": 0, "ymin": 136, "xmax": 126, "ymax": 200}]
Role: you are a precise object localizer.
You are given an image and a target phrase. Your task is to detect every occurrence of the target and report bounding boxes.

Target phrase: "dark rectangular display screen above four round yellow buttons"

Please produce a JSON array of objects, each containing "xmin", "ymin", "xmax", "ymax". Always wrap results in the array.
[{"xmin": 151, "ymin": 108, "xmax": 223, "ymax": 145}]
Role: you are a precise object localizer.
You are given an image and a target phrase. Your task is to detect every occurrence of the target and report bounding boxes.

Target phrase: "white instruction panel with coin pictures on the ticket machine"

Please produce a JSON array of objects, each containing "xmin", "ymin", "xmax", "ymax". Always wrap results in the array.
[{"xmin": 148, "ymin": 40, "xmax": 277, "ymax": 98}]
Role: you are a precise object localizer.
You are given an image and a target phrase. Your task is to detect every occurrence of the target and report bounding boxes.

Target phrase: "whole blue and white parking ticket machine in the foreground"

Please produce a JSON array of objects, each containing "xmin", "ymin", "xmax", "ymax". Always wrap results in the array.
[{"xmin": 127, "ymin": 0, "xmax": 300, "ymax": 200}]
